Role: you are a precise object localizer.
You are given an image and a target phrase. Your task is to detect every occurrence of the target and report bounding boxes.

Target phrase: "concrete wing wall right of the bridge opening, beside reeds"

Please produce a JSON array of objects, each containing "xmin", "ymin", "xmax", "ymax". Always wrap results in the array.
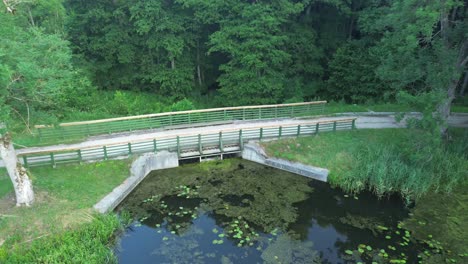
[{"xmin": 242, "ymin": 142, "xmax": 328, "ymax": 182}]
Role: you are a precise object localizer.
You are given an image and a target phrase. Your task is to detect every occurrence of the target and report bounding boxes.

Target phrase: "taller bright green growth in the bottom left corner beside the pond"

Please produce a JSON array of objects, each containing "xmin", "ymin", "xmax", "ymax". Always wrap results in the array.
[{"xmin": 0, "ymin": 215, "xmax": 122, "ymax": 264}]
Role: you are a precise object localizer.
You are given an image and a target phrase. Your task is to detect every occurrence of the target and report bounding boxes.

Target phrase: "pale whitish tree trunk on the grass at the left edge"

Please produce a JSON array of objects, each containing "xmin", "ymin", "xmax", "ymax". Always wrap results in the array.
[{"xmin": 0, "ymin": 133, "xmax": 34, "ymax": 206}]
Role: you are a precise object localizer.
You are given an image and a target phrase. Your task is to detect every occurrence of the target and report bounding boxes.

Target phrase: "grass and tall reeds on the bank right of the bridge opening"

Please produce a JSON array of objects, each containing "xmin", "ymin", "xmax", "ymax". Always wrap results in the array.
[{"xmin": 264, "ymin": 129, "xmax": 468, "ymax": 201}]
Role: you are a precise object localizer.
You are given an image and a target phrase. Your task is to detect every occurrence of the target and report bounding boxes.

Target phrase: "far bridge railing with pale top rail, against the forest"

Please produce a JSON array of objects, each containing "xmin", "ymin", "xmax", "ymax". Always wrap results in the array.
[{"xmin": 35, "ymin": 101, "xmax": 327, "ymax": 141}]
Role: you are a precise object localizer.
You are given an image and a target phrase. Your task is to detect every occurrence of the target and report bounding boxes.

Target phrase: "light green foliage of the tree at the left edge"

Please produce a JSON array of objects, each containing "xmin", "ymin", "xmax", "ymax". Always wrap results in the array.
[{"xmin": 0, "ymin": 10, "xmax": 95, "ymax": 126}]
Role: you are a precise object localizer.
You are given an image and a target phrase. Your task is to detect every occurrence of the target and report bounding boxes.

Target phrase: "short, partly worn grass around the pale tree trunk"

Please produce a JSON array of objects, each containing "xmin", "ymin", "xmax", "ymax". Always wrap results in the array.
[{"xmin": 0, "ymin": 160, "xmax": 130, "ymax": 262}]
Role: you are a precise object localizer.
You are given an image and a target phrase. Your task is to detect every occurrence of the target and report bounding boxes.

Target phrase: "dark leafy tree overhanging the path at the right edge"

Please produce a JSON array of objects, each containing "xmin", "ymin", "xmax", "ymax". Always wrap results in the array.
[{"xmin": 360, "ymin": 0, "xmax": 468, "ymax": 136}]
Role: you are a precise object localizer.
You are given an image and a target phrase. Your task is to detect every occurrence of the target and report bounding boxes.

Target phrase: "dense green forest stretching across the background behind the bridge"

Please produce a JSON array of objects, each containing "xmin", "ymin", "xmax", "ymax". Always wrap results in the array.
[{"xmin": 0, "ymin": 0, "xmax": 468, "ymax": 135}]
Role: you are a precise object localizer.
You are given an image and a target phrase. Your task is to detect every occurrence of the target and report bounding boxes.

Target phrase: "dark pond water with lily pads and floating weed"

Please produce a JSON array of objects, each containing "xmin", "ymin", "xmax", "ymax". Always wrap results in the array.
[{"xmin": 115, "ymin": 159, "xmax": 422, "ymax": 263}]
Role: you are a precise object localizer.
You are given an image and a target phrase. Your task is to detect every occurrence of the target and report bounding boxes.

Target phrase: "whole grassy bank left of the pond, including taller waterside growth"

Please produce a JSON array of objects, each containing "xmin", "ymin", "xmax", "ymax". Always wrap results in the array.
[{"xmin": 0, "ymin": 161, "xmax": 129, "ymax": 263}]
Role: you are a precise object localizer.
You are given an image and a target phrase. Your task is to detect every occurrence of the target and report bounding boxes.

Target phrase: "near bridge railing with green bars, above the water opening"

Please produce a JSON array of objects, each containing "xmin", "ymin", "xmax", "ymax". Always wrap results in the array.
[{"xmin": 19, "ymin": 118, "xmax": 356, "ymax": 167}]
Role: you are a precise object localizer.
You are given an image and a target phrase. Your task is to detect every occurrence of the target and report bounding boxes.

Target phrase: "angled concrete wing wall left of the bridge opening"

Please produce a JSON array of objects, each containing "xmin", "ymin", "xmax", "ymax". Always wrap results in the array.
[{"xmin": 94, "ymin": 151, "xmax": 179, "ymax": 213}]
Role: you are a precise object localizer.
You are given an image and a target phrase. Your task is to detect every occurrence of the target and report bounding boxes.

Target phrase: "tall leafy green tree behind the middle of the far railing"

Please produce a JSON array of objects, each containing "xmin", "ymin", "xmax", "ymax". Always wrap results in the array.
[{"xmin": 186, "ymin": 0, "xmax": 303, "ymax": 105}]
